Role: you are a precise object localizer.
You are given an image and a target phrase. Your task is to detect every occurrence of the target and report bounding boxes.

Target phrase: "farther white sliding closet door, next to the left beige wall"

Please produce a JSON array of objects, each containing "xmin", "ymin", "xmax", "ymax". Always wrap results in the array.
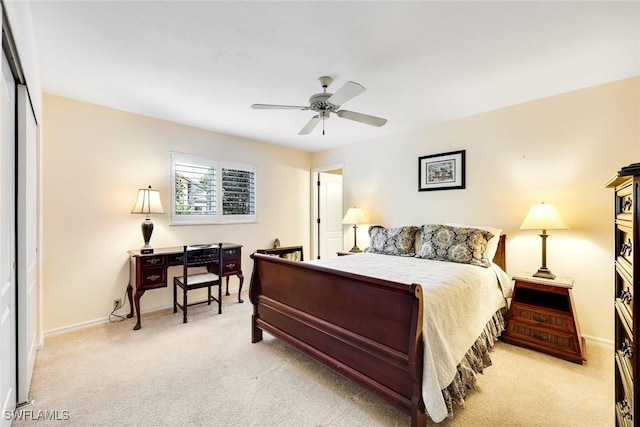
[{"xmin": 17, "ymin": 85, "xmax": 39, "ymax": 403}]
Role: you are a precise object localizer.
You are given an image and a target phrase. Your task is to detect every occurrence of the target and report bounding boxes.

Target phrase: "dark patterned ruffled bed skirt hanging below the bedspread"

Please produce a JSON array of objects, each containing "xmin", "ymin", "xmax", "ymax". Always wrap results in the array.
[{"xmin": 442, "ymin": 308, "xmax": 506, "ymax": 418}]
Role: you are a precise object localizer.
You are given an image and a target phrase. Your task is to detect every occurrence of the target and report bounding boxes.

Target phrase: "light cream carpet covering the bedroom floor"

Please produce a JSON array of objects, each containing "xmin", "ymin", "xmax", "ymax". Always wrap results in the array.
[{"xmin": 13, "ymin": 295, "xmax": 614, "ymax": 427}]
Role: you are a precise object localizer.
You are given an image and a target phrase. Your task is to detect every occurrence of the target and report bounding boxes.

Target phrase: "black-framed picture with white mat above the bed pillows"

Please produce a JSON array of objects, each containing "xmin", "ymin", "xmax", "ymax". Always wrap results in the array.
[{"xmin": 418, "ymin": 150, "xmax": 466, "ymax": 191}]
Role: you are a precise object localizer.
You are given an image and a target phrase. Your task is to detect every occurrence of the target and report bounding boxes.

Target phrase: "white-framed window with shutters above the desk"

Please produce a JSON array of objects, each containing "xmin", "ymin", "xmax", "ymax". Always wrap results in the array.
[{"xmin": 171, "ymin": 152, "xmax": 257, "ymax": 225}]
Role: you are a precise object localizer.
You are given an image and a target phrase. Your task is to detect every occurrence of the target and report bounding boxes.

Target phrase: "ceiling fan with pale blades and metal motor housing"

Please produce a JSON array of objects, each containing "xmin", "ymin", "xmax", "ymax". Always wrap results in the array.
[{"xmin": 251, "ymin": 76, "xmax": 387, "ymax": 135}]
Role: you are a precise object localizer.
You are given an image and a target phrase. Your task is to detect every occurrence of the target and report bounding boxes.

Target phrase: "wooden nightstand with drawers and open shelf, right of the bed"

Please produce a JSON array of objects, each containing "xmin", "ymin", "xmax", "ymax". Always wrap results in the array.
[{"xmin": 503, "ymin": 273, "xmax": 585, "ymax": 364}]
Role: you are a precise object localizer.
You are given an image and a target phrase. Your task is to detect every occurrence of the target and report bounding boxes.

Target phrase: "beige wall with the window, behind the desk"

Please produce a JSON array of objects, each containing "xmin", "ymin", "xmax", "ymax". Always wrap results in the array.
[{"xmin": 42, "ymin": 95, "xmax": 311, "ymax": 333}]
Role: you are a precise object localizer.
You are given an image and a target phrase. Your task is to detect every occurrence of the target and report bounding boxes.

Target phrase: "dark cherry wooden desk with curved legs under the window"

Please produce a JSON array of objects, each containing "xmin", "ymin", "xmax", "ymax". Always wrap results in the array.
[{"xmin": 127, "ymin": 243, "xmax": 244, "ymax": 330}]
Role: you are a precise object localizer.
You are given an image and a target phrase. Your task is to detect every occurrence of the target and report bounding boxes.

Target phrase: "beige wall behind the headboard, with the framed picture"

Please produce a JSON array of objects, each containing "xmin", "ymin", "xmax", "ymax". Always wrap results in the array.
[{"xmin": 313, "ymin": 77, "xmax": 640, "ymax": 344}]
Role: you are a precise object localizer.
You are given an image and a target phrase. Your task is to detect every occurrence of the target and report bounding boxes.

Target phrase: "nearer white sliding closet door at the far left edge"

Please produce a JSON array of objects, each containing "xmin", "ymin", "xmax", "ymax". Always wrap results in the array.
[{"xmin": 0, "ymin": 42, "xmax": 16, "ymax": 427}]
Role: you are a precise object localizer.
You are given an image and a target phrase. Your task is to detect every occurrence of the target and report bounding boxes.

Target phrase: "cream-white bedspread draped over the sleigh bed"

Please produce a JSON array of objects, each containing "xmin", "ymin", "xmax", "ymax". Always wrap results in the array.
[{"xmin": 308, "ymin": 253, "xmax": 511, "ymax": 422}]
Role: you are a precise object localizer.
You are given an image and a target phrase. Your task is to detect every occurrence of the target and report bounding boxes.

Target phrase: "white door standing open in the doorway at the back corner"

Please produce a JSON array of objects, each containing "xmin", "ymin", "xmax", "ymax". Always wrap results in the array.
[{"xmin": 316, "ymin": 171, "xmax": 344, "ymax": 258}]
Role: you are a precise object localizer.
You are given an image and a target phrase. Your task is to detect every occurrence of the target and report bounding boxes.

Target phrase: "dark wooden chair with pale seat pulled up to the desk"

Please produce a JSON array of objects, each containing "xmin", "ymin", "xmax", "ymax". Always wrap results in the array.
[{"xmin": 173, "ymin": 243, "xmax": 222, "ymax": 323}]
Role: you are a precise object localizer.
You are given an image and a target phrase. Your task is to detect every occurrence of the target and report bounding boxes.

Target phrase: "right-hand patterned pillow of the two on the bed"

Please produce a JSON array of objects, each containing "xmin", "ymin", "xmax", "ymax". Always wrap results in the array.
[{"xmin": 416, "ymin": 224, "xmax": 493, "ymax": 267}]
